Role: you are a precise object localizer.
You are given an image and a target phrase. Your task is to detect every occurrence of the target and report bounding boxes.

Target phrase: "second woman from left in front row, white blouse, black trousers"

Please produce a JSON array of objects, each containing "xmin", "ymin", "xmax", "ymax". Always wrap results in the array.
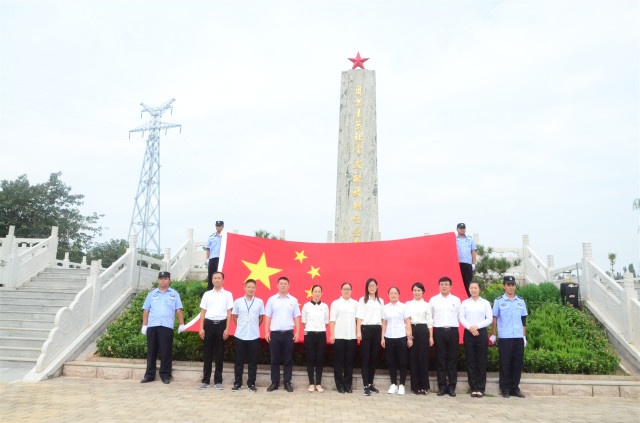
[{"xmin": 329, "ymin": 282, "xmax": 358, "ymax": 394}]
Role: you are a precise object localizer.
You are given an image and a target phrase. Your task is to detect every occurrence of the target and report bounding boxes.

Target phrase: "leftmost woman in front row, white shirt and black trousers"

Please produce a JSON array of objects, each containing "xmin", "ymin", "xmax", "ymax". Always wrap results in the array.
[{"xmin": 302, "ymin": 285, "xmax": 329, "ymax": 392}]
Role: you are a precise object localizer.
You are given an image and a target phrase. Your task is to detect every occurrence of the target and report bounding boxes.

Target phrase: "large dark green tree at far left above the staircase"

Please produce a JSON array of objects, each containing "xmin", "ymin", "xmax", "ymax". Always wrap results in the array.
[{"xmin": 0, "ymin": 172, "xmax": 104, "ymax": 261}]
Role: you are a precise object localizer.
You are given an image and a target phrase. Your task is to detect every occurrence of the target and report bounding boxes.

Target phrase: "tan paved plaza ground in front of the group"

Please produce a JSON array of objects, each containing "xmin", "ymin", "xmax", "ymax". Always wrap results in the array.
[{"xmin": 0, "ymin": 377, "xmax": 640, "ymax": 423}]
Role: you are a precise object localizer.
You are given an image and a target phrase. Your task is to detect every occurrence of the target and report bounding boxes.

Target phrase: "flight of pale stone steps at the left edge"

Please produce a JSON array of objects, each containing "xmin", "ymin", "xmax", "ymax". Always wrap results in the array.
[{"xmin": 0, "ymin": 268, "xmax": 89, "ymax": 363}]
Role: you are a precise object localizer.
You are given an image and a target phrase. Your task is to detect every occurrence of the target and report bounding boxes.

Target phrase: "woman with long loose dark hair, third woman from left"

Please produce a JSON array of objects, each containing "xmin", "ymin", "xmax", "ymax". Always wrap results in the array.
[{"xmin": 356, "ymin": 278, "xmax": 384, "ymax": 396}]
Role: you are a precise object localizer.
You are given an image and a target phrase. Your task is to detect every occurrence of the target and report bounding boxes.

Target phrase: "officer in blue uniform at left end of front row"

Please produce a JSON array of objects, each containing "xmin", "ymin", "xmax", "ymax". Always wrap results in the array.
[{"xmin": 140, "ymin": 272, "xmax": 185, "ymax": 384}]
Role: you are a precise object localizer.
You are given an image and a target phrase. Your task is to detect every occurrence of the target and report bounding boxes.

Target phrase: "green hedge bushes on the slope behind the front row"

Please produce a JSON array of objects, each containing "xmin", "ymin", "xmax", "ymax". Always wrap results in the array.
[{"xmin": 97, "ymin": 281, "xmax": 619, "ymax": 374}]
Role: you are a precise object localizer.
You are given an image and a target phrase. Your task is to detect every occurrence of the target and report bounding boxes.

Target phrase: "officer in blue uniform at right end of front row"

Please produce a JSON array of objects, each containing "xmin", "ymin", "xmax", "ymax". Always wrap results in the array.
[{"xmin": 490, "ymin": 276, "xmax": 528, "ymax": 398}]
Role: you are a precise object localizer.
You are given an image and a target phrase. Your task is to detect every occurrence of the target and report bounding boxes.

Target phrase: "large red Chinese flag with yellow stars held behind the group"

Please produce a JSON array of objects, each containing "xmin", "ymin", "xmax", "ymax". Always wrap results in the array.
[{"xmin": 187, "ymin": 233, "xmax": 467, "ymax": 342}]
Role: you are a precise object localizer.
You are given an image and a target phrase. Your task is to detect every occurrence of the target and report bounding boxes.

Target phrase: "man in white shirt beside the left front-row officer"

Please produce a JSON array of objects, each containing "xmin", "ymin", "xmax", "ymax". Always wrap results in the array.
[{"xmin": 200, "ymin": 272, "xmax": 233, "ymax": 389}]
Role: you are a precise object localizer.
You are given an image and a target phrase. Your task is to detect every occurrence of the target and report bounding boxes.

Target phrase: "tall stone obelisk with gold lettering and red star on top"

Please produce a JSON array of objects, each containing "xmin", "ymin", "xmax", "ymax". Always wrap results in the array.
[{"xmin": 335, "ymin": 52, "xmax": 380, "ymax": 242}]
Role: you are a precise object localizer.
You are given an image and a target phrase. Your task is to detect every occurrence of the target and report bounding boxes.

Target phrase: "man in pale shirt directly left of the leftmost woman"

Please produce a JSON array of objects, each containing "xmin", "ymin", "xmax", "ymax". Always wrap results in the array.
[{"xmin": 264, "ymin": 276, "xmax": 300, "ymax": 392}]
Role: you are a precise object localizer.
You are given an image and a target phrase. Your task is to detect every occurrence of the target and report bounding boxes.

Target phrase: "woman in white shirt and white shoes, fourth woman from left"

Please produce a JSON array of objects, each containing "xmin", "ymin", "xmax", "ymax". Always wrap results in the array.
[{"xmin": 380, "ymin": 286, "xmax": 413, "ymax": 395}]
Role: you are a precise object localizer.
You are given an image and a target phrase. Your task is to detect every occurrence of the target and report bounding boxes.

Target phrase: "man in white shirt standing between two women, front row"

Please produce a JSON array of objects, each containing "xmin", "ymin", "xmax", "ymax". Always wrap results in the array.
[{"xmin": 429, "ymin": 276, "xmax": 460, "ymax": 397}]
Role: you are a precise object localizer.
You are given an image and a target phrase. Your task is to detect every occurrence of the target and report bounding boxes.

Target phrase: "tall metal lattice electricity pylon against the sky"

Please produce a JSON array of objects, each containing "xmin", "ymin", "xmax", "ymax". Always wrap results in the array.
[{"xmin": 129, "ymin": 98, "xmax": 182, "ymax": 254}]
